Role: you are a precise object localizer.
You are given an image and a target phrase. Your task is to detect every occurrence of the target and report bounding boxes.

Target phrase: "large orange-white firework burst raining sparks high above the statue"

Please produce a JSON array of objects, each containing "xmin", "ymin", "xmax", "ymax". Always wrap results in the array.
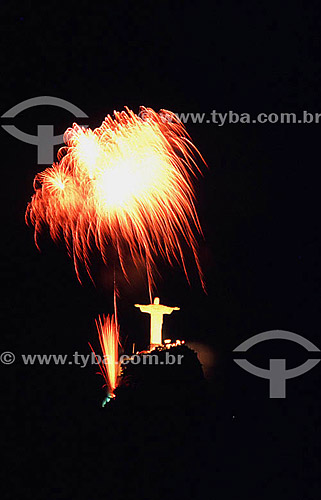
[{"xmin": 26, "ymin": 107, "xmax": 203, "ymax": 289}]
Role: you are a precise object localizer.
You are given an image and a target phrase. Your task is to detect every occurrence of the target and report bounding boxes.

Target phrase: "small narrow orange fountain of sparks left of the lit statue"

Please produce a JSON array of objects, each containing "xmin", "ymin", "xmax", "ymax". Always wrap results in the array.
[{"xmin": 89, "ymin": 315, "xmax": 119, "ymax": 401}]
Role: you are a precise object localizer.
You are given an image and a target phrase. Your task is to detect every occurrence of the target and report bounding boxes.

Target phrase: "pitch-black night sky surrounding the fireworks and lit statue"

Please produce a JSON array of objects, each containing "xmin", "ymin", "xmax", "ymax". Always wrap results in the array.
[{"xmin": 1, "ymin": 1, "xmax": 321, "ymax": 500}]
